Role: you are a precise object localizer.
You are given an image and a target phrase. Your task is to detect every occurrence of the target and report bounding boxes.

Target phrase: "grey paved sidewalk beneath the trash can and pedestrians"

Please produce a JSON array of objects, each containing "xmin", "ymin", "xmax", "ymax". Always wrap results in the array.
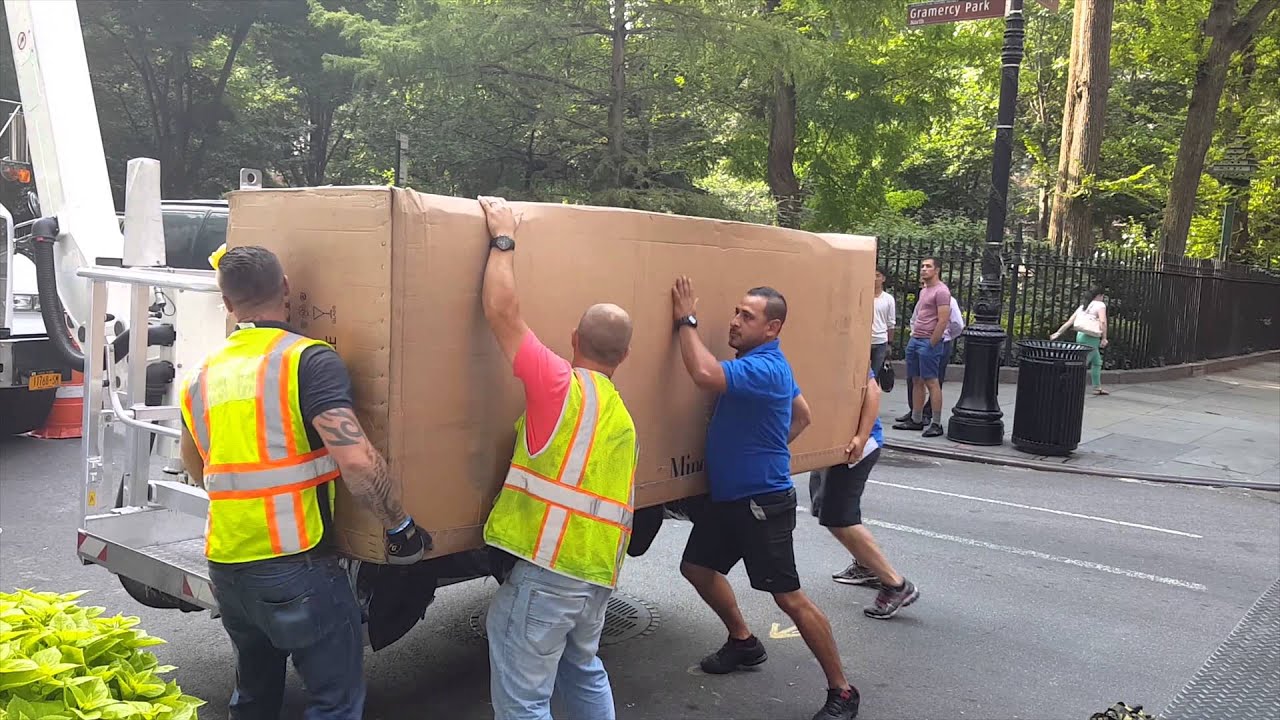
[{"xmin": 881, "ymin": 360, "xmax": 1280, "ymax": 489}]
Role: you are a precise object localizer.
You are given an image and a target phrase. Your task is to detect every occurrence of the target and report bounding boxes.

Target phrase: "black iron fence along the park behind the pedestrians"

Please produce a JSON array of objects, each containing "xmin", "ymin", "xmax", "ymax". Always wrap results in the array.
[{"xmin": 877, "ymin": 230, "xmax": 1280, "ymax": 369}]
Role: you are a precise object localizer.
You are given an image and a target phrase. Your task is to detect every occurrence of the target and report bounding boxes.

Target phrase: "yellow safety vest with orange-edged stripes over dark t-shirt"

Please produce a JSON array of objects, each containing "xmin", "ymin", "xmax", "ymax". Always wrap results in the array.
[{"xmin": 182, "ymin": 325, "xmax": 338, "ymax": 562}]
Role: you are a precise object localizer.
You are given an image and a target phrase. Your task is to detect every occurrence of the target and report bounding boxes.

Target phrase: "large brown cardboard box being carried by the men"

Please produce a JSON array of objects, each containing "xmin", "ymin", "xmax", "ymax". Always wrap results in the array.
[{"xmin": 228, "ymin": 187, "xmax": 876, "ymax": 561}]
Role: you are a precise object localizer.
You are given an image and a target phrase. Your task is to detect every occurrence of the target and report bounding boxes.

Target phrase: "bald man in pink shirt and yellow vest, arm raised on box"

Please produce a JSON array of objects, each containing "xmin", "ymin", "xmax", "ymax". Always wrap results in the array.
[{"xmin": 480, "ymin": 197, "xmax": 636, "ymax": 720}]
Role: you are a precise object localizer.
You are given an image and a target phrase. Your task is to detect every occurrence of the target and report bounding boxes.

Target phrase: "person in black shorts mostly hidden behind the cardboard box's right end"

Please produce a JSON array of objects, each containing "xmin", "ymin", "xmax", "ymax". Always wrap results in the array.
[{"xmin": 809, "ymin": 370, "xmax": 920, "ymax": 620}]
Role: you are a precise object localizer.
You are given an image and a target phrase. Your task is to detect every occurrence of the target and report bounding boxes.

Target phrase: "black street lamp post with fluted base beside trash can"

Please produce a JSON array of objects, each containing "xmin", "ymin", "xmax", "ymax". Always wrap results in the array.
[{"xmin": 947, "ymin": 0, "xmax": 1025, "ymax": 445}]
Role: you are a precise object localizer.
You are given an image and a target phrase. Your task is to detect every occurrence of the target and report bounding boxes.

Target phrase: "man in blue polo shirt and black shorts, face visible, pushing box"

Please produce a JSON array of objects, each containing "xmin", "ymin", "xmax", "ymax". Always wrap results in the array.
[{"xmin": 671, "ymin": 277, "xmax": 860, "ymax": 720}]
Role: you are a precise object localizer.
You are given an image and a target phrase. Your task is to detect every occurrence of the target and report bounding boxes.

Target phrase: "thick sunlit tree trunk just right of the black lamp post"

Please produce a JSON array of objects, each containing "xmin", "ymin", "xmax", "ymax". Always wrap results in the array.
[{"xmin": 1050, "ymin": 0, "xmax": 1115, "ymax": 255}]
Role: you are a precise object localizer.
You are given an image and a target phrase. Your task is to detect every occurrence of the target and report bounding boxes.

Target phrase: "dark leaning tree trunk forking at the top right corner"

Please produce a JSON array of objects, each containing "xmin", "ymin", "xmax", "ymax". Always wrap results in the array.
[{"xmin": 1160, "ymin": 0, "xmax": 1280, "ymax": 258}]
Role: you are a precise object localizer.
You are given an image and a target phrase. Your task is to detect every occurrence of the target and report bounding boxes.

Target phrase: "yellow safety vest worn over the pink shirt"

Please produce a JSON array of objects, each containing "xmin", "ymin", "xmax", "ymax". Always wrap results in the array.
[{"xmin": 484, "ymin": 368, "xmax": 636, "ymax": 588}]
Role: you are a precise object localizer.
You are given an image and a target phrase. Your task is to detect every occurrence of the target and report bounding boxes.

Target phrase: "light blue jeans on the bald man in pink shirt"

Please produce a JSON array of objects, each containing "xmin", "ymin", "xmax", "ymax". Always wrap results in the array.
[{"xmin": 485, "ymin": 560, "xmax": 614, "ymax": 720}]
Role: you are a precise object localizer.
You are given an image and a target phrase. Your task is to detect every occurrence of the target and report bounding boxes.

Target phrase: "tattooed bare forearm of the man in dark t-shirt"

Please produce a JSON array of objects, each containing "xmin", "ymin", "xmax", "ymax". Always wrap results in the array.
[{"xmin": 314, "ymin": 407, "xmax": 408, "ymax": 530}]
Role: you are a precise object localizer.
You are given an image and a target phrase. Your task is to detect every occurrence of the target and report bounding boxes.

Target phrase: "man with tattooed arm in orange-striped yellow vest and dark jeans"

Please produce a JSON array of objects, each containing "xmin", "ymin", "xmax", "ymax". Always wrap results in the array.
[{"xmin": 180, "ymin": 247, "xmax": 430, "ymax": 720}]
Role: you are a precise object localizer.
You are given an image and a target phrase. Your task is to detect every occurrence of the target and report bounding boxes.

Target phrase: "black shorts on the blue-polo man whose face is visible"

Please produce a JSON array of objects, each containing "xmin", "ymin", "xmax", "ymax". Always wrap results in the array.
[{"xmin": 684, "ymin": 488, "xmax": 800, "ymax": 593}]
